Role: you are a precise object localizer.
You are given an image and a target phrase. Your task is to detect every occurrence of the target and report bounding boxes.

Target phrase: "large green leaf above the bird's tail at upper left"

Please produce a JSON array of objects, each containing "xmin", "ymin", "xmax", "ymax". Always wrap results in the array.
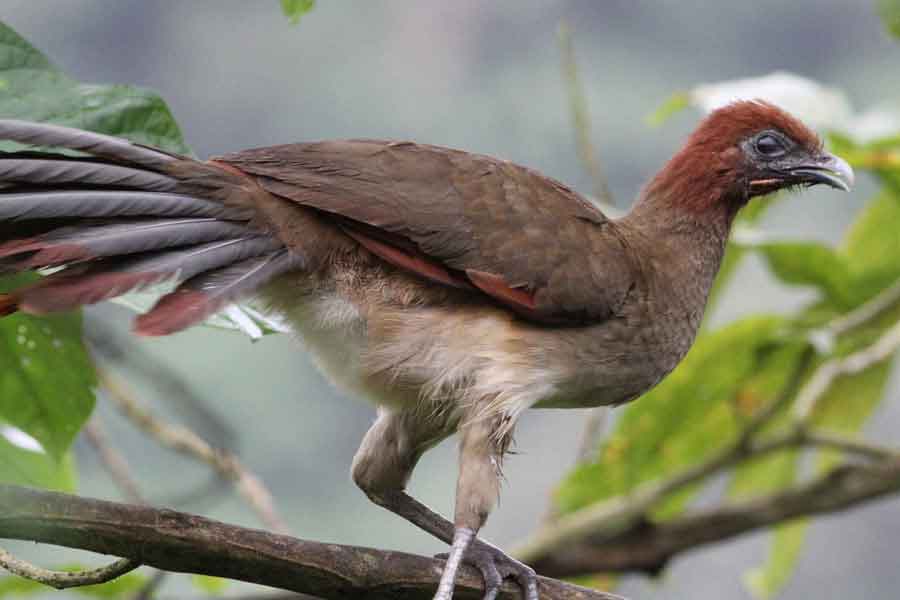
[{"xmin": 0, "ymin": 22, "xmax": 190, "ymax": 153}]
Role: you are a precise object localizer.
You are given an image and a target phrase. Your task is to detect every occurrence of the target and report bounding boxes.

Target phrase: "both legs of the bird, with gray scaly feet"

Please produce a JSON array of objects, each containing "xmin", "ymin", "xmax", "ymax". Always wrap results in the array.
[{"xmin": 353, "ymin": 409, "xmax": 538, "ymax": 600}]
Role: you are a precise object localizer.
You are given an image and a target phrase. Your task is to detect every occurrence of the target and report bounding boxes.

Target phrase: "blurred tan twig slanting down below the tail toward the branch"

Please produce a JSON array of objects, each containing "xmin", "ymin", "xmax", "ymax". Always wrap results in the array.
[{"xmin": 97, "ymin": 366, "xmax": 288, "ymax": 533}]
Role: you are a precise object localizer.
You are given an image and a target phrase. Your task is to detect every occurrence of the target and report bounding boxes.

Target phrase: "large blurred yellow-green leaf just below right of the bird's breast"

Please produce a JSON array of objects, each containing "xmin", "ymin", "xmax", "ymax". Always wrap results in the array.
[{"xmin": 556, "ymin": 317, "xmax": 781, "ymax": 518}]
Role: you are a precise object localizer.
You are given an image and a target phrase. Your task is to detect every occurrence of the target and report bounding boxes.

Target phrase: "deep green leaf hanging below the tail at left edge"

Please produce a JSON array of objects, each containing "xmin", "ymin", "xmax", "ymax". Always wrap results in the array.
[{"xmin": 0, "ymin": 275, "xmax": 96, "ymax": 459}]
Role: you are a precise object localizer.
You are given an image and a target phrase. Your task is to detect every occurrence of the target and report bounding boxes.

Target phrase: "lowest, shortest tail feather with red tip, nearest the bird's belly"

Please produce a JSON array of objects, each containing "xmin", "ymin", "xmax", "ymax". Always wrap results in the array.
[{"xmin": 134, "ymin": 249, "xmax": 304, "ymax": 336}]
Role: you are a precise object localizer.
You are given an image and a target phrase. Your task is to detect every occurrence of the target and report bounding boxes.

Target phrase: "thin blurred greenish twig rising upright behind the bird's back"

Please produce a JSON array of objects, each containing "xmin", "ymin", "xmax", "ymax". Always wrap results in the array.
[{"xmin": 558, "ymin": 20, "xmax": 615, "ymax": 207}]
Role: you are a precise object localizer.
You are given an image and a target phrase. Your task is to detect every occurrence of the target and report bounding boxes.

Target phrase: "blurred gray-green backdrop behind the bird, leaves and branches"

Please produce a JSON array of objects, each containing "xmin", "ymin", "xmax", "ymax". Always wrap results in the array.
[{"xmin": 0, "ymin": 0, "xmax": 900, "ymax": 600}]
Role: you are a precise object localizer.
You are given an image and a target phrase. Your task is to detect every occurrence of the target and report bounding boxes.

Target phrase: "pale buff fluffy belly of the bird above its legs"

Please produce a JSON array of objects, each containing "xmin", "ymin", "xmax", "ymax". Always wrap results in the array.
[{"xmin": 270, "ymin": 292, "xmax": 559, "ymax": 415}]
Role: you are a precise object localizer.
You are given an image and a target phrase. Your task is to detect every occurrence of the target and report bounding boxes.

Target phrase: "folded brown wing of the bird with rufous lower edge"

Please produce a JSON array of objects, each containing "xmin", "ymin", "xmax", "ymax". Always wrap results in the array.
[{"xmin": 215, "ymin": 140, "xmax": 631, "ymax": 323}]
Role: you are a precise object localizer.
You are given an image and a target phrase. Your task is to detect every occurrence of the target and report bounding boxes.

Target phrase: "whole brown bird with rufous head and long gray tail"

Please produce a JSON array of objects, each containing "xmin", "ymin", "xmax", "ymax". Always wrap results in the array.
[{"xmin": 0, "ymin": 100, "xmax": 854, "ymax": 600}]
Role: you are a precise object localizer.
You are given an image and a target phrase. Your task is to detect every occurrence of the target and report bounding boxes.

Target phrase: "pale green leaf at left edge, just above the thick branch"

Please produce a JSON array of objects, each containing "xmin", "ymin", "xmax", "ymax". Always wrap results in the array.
[{"xmin": 0, "ymin": 424, "xmax": 75, "ymax": 492}]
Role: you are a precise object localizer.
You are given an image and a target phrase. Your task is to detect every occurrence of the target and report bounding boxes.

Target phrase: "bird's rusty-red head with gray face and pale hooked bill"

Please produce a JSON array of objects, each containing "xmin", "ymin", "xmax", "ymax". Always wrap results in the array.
[{"xmin": 647, "ymin": 100, "xmax": 853, "ymax": 215}]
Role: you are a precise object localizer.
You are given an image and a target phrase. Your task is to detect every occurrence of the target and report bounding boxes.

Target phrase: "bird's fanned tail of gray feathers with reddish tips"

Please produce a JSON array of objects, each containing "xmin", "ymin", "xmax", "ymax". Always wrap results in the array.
[{"xmin": 0, "ymin": 119, "xmax": 303, "ymax": 335}]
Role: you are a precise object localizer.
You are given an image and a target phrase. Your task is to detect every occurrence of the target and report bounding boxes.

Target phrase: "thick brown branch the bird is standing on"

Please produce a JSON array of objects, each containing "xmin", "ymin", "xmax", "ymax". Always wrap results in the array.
[{"xmin": 0, "ymin": 485, "xmax": 621, "ymax": 600}]
